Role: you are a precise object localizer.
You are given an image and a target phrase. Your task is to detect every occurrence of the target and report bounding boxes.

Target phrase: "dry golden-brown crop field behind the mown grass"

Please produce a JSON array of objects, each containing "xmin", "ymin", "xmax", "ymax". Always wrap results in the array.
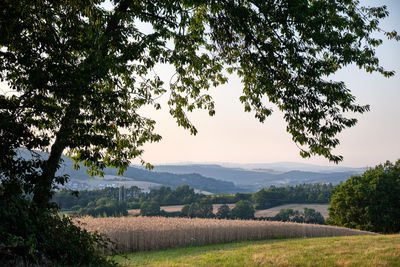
[{"xmin": 75, "ymin": 217, "xmax": 374, "ymax": 253}]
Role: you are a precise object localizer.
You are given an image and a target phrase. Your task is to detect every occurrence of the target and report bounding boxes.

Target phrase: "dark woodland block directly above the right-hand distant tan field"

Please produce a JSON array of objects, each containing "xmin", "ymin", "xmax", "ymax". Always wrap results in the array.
[{"xmin": 252, "ymin": 183, "xmax": 333, "ymax": 209}]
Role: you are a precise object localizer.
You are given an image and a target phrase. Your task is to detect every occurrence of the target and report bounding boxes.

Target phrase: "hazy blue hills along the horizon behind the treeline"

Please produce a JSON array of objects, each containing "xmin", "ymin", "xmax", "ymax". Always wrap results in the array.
[{"xmin": 14, "ymin": 151, "xmax": 362, "ymax": 193}]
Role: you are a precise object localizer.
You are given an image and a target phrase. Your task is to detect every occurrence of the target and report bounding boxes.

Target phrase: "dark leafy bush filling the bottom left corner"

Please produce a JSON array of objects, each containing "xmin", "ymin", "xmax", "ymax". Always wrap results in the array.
[{"xmin": 0, "ymin": 185, "xmax": 112, "ymax": 266}]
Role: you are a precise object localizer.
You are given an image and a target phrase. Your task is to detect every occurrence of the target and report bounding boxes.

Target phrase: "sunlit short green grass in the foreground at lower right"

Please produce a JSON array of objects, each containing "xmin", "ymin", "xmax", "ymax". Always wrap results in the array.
[{"xmin": 112, "ymin": 234, "xmax": 400, "ymax": 267}]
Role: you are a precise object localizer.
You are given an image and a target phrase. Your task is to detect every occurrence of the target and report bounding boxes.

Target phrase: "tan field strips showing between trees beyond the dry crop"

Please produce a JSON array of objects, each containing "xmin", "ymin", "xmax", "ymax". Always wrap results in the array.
[{"xmin": 128, "ymin": 204, "xmax": 329, "ymax": 219}]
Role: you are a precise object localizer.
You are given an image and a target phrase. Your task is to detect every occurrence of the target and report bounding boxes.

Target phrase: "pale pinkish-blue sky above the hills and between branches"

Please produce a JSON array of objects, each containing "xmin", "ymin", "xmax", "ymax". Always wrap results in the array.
[{"xmin": 0, "ymin": 0, "xmax": 400, "ymax": 167}]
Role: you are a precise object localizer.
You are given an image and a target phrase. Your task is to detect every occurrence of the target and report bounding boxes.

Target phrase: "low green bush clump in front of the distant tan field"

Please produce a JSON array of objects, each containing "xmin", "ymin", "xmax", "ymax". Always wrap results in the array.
[{"xmin": 271, "ymin": 208, "xmax": 325, "ymax": 224}]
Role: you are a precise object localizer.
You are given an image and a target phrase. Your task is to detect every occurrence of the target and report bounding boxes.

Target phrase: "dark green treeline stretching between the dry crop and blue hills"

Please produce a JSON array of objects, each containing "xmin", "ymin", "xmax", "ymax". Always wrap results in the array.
[{"xmin": 53, "ymin": 183, "xmax": 333, "ymax": 221}]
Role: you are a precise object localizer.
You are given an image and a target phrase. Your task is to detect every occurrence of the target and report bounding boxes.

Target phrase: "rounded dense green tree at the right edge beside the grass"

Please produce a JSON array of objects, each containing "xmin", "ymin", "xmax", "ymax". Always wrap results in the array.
[{"xmin": 327, "ymin": 160, "xmax": 400, "ymax": 233}]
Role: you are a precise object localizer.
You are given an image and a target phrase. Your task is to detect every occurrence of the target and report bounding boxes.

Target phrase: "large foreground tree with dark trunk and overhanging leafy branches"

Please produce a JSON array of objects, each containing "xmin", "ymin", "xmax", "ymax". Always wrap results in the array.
[{"xmin": 0, "ymin": 0, "xmax": 398, "ymax": 207}]
